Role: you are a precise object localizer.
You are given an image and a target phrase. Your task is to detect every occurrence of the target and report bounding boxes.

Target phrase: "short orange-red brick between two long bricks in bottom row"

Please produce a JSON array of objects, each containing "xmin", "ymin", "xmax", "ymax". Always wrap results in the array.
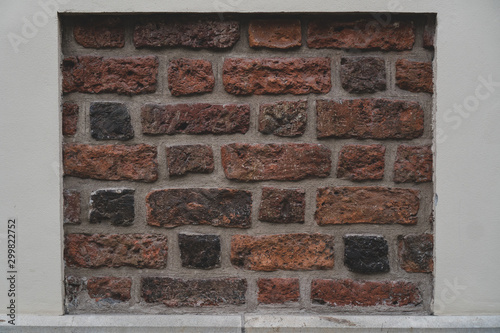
[{"xmin": 257, "ymin": 278, "xmax": 300, "ymax": 304}]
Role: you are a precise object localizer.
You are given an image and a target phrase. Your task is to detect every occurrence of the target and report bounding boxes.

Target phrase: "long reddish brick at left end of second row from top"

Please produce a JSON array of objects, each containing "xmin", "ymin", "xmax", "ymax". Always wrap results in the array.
[{"xmin": 62, "ymin": 56, "xmax": 158, "ymax": 95}]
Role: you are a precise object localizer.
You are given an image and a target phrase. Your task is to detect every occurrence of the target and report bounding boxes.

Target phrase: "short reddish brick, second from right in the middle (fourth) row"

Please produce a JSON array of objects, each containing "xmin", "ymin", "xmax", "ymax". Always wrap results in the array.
[{"xmin": 337, "ymin": 145, "xmax": 385, "ymax": 180}]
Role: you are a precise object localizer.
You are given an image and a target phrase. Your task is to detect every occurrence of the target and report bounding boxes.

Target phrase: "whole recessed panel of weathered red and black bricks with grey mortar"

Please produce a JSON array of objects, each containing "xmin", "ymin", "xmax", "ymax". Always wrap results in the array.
[{"xmin": 61, "ymin": 14, "xmax": 435, "ymax": 313}]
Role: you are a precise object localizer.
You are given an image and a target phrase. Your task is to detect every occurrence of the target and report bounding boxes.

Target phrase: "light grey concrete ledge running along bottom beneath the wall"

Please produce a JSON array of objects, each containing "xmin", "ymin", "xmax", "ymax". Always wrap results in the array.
[{"xmin": 0, "ymin": 315, "xmax": 500, "ymax": 333}]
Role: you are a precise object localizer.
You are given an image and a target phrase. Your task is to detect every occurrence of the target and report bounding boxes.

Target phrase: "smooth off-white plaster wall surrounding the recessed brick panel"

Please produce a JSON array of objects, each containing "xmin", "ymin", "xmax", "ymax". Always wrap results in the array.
[{"xmin": 0, "ymin": 0, "xmax": 500, "ymax": 315}]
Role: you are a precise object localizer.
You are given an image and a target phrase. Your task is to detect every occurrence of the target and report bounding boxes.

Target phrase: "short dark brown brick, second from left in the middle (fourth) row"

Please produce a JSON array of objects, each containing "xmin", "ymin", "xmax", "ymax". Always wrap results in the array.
[{"xmin": 166, "ymin": 145, "xmax": 214, "ymax": 176}]
